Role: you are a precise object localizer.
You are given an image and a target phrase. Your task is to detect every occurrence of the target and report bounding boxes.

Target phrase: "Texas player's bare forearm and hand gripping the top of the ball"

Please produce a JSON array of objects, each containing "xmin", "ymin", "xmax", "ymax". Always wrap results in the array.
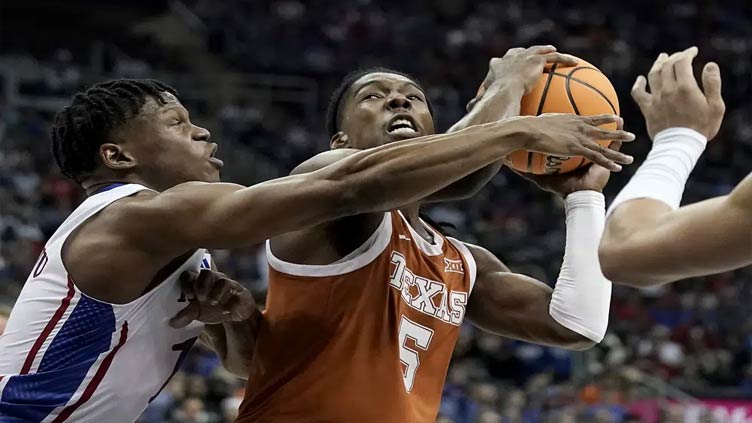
[{"xmin": 424, "ymin": 45, "xmax": 577, "ymax": 202}]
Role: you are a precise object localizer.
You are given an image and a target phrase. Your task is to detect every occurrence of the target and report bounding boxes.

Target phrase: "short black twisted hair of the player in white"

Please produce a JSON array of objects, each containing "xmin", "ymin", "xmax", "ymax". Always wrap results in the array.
[{"xmin": 51, "ymin": 79, "xmax": 177, "ymax": 183}]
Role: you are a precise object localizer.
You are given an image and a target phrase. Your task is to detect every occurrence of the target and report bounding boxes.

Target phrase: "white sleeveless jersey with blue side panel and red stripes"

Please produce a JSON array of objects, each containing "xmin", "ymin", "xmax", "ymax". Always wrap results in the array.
[{"xmin": 0, "ymin": 184, "xmax": 211, "ymax": 423}]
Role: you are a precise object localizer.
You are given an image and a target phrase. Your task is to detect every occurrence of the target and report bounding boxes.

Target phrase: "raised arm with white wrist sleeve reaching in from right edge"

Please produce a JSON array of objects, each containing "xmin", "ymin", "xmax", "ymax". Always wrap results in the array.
[{"xmin": 600, "ymin": 47, "xmax": 752, "ymax": 286}]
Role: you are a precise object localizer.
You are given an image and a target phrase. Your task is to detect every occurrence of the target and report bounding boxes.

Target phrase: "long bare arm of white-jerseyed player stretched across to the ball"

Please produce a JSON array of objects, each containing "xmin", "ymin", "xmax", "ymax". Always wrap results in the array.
[{"xmin": 119, "ymin": 115, "xmax": 634, "ymax": 257}]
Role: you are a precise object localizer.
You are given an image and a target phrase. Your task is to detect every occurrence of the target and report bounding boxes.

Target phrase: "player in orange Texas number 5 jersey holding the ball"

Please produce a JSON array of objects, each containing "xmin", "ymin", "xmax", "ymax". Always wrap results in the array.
[{"xmin": 238, "ymin": 47, "xmax": 628, "ymax": 423}]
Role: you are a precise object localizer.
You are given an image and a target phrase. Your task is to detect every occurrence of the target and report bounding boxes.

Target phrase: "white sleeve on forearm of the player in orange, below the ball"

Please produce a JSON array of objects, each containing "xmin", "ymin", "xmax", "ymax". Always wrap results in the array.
[{"xmin": 548, "ymin": 191, "xmax": 611, "ymax": 342}]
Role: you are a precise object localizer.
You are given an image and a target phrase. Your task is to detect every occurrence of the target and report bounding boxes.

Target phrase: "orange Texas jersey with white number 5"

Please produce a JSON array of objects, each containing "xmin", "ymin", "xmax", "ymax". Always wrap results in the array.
[{"xmin": 238, "ymin": 212, "xmax": 476, "ymax": 423}]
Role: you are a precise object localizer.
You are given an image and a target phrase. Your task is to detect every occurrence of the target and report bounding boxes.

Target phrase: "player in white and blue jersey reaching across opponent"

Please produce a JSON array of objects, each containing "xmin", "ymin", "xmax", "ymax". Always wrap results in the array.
[{"xmin": 0, "ymin": 76, "xmax": 633, "ymax": 423}]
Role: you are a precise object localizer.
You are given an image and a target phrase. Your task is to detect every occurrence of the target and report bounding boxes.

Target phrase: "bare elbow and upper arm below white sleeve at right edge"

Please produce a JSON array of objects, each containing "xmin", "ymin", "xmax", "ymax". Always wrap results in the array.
[{"xmin": 600, "ymin": 174, "xmax": 752, "ymax": 287}]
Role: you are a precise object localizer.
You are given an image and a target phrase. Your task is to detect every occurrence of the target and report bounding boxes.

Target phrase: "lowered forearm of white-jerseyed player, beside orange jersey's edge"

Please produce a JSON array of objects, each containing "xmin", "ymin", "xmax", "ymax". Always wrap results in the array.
[{"xmin": 201, "ymin": 312, "xmax": 261, "ymax": 379}]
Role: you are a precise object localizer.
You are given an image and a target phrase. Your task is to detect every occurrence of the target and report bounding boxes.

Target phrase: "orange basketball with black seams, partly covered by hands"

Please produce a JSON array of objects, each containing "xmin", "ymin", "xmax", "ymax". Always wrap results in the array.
[{"xmin": 478, "ymin": 59, "xmax": 619, "ymax": 175}]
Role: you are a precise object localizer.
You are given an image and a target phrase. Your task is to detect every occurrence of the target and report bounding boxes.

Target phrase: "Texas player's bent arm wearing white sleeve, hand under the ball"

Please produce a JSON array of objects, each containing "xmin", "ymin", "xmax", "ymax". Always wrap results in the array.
[{"xmin": 467, "ymin": 161, "xmax": 617, "ymax": 350}]
